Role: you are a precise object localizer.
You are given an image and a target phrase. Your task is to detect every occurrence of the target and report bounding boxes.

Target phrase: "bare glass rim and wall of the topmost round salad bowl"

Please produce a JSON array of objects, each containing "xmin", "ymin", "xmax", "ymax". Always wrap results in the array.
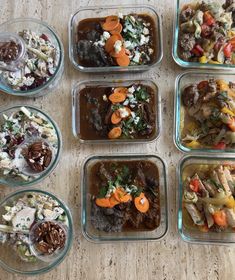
[{"xmin": 0, "ymin": 18, "xmax": 64, "ymax": 97}]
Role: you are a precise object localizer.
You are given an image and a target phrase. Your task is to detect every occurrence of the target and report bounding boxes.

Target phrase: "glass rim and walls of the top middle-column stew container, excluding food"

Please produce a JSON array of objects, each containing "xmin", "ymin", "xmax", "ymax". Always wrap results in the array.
[{"xmin": 68, "ymin": 5, "xmax": 163, "ymax": 73}]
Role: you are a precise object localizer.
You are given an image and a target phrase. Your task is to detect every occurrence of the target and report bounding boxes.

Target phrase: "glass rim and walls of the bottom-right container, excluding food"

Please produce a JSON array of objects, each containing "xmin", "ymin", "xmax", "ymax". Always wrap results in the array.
[{"xmin": 177, "ymin": 155, "xmax": 235, "ymax": 244}]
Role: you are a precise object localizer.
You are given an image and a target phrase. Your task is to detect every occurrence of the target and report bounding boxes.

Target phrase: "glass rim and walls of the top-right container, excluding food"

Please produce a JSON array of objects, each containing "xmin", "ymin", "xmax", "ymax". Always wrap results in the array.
[{"xmin": 172, "ymin": 0, "xmax": 235, "ymax": 71}]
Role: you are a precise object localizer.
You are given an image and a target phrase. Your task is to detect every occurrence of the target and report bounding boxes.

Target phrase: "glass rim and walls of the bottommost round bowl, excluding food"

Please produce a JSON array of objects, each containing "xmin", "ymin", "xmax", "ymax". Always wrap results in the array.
[{"xmin": 0, "ymin": 188, "xmax": 73, "ymax": 275}]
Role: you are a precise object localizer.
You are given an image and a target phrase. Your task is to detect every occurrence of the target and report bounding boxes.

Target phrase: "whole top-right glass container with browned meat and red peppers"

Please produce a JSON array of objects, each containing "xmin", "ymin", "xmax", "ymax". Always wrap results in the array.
[{"xmin": 172, "ymin": 0, "xmax": 235, "ymax": 70}]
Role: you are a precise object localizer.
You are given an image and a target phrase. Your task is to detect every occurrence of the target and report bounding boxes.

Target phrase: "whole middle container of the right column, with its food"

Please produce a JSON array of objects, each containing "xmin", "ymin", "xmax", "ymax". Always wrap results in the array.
[{"xmin": 174, "ymin": 71, "xmax": 235, "ymax": 153}]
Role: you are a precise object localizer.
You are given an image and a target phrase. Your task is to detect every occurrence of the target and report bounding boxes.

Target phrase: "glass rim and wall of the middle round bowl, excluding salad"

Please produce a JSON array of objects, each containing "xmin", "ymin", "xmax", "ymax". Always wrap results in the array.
[{"xmin": 0, "ymin": 105, "xmax": 62, "ymax": 187}]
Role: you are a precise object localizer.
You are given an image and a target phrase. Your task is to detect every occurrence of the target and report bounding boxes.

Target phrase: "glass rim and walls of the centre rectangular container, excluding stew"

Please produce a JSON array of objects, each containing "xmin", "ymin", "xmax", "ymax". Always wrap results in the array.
[{"xmin": 72, "ymin": 79, "xmax": 161, "ymax": 144}]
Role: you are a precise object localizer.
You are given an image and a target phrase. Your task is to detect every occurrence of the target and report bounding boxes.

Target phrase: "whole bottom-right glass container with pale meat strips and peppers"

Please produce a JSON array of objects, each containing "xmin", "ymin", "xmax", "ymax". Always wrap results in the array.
[{"xmin": 177, "ymin": 155, "xmax": 235, "ymax": 244}]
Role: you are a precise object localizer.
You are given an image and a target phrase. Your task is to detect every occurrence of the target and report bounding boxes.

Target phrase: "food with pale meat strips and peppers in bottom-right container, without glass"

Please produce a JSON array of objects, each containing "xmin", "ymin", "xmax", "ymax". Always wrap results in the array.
[{"xmin": 182, "ymin": 163, "xmax": 235, "ymax": 232}]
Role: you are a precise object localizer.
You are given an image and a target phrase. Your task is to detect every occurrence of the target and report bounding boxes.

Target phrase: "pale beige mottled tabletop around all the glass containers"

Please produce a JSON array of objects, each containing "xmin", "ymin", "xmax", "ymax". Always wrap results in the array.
[{"xmin": 0, "ymin": 0, "xmax": 235, "ymax": 280}]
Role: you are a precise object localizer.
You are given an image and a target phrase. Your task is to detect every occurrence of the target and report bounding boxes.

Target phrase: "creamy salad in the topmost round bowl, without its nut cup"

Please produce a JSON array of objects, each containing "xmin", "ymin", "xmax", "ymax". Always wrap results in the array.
[{"xmin": 0, "ymin": 29, "xmax": 60, "ymax": 91}]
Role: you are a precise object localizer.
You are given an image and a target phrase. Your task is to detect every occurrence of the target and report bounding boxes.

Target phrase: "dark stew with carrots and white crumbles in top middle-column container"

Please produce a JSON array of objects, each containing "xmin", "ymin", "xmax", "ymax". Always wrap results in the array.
[{"xmin": 76, "ymin": 13, "xmax": 157, "ymax": 67}]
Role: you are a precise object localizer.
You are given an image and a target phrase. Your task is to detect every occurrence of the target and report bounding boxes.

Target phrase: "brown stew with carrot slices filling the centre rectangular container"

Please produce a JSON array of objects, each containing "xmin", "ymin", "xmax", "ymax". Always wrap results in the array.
[{"xmin": 79, "ymin": 83, "xmax": 157, "ymax": 140}]
